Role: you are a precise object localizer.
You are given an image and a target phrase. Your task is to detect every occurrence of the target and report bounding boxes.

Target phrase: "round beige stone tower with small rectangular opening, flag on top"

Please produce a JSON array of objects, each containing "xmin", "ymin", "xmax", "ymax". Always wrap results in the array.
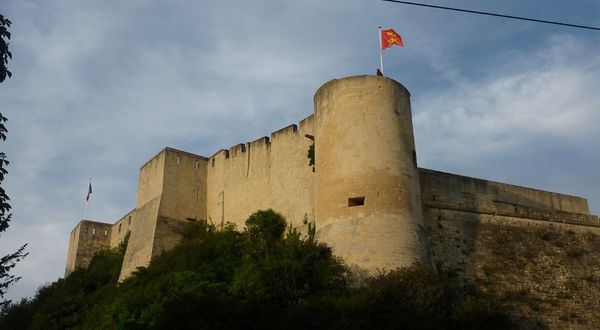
[{"xmin": 314, "ymin": 76, "xmax": 429, "ymax": 274}]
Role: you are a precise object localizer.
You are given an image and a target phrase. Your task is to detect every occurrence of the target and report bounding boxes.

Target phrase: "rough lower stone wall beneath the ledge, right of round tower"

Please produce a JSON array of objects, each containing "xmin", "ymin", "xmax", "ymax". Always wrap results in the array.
[{"xmin": 423, "ymin": 204, "xmax": 600, "ymax": 329}]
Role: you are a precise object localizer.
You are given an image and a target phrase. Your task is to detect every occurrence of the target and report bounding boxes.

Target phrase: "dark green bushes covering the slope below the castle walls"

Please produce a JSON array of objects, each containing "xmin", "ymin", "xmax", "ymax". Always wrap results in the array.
[{"xmin": 0, "ymin": 210, "xmax": 517, "ymax": 329}]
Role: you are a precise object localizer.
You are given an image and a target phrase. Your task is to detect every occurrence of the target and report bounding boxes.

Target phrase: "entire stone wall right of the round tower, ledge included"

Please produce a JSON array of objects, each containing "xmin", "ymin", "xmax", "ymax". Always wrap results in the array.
[{"xmin": 420, "ymin": 169, "xmax": 600, "ymax": 329}]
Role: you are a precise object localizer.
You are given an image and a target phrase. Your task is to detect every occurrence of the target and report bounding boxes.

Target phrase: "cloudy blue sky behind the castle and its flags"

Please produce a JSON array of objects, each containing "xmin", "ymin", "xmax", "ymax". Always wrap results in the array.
[{"xmin": 0, "ymin": 0, "xmax": 600, "ymax": 299}]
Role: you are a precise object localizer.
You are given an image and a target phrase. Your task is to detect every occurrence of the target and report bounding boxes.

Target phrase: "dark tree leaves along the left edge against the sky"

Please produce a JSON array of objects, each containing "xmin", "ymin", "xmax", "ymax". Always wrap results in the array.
[{"xmin": 0, "ymin": 14, "xmax": 28, "ymax": 304}]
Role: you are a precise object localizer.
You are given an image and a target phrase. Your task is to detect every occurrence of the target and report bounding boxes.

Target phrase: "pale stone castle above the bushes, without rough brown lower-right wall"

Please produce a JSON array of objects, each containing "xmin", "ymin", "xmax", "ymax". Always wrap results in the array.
[{"xmin": 66, "ymin": 76, "xmax": 600, "ymax": 286}]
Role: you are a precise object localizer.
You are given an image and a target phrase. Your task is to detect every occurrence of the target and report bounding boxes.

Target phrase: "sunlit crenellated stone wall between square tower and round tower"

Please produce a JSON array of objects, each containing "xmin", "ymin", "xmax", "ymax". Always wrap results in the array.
[{"xmin": 206, "ymin": 115, "xmax": 315, "ymax": 230}]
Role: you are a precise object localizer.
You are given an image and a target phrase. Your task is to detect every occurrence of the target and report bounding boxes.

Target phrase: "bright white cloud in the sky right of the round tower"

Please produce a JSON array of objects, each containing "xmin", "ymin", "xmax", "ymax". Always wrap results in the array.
[{"xmin": 414, "ymin": 33, "xmax": 600, "ymax": 157}]
